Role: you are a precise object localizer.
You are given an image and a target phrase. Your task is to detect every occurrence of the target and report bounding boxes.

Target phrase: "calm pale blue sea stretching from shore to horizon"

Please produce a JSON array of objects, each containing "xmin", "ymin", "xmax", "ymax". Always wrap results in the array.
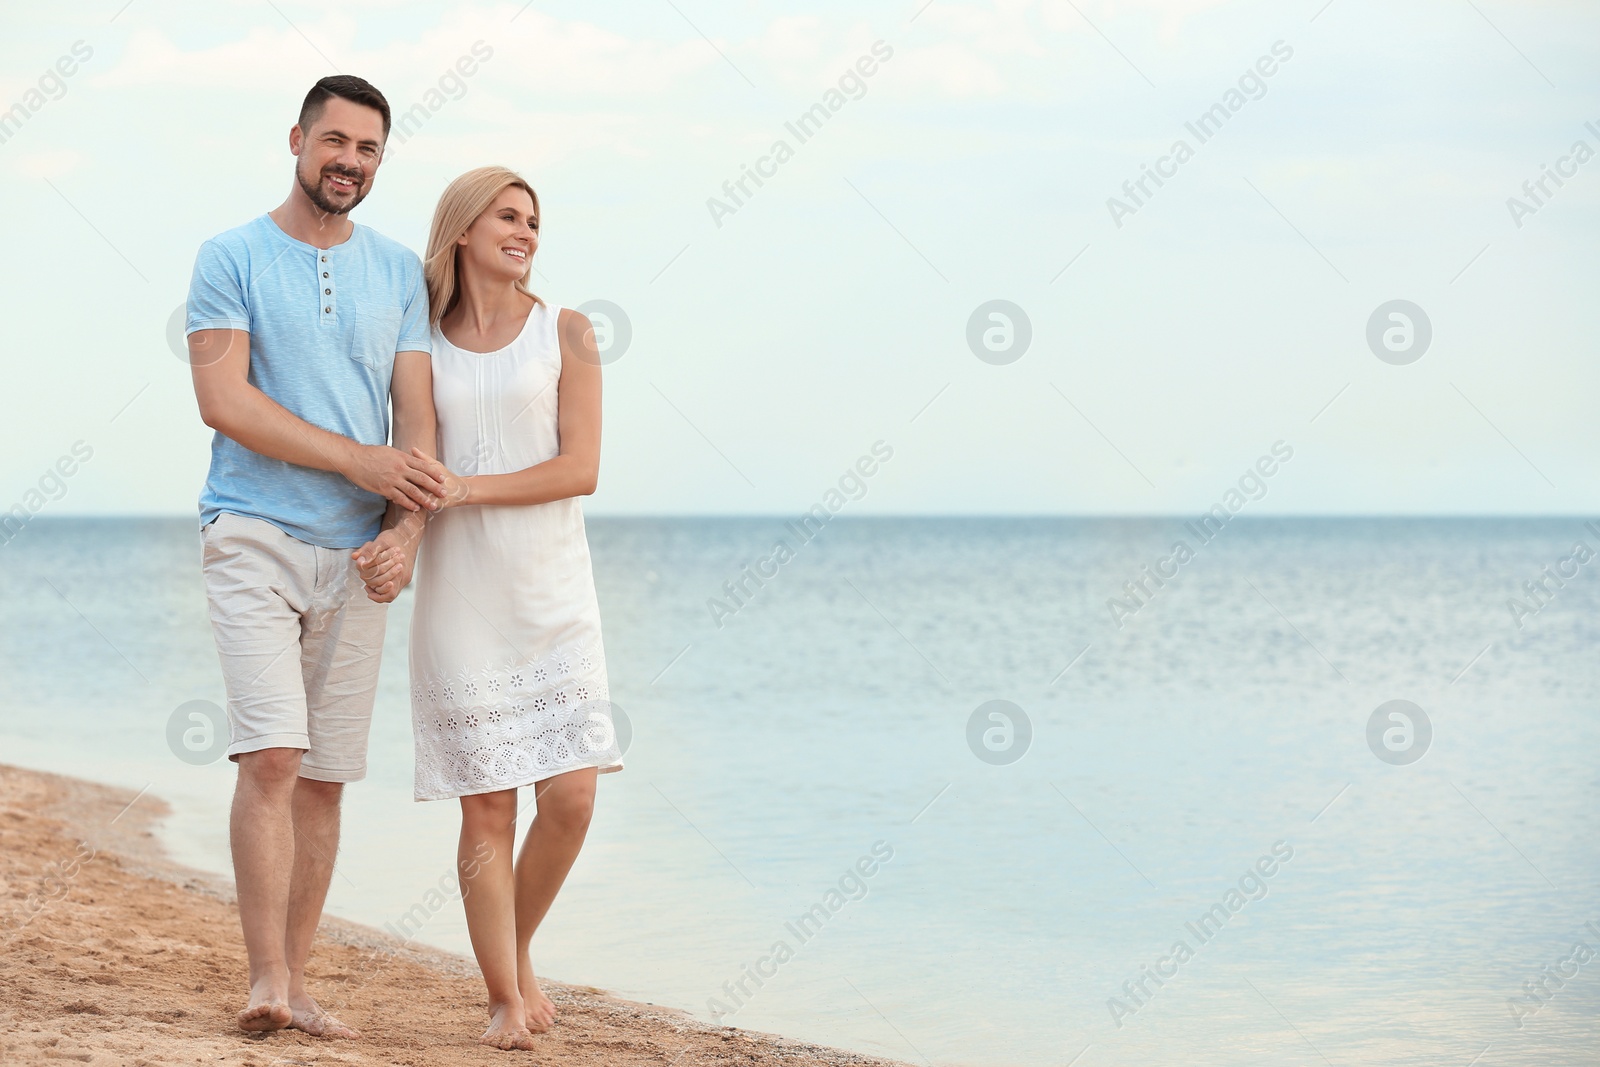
[{"xmin": 0, "ymin": 517, "xmax": 1600, "ymax": 1067}]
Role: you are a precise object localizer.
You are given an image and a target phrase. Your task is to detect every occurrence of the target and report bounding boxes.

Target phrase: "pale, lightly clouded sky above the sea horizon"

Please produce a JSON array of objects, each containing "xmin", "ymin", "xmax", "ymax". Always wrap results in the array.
[{"xmin": 0, "ymin": 0, "xmax": 1600, "ymax": 515}]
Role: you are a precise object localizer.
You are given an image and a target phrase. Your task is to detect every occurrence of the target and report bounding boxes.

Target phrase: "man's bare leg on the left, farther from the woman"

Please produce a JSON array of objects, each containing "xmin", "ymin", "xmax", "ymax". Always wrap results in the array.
[{"xmin": 229, "ymin": 749, "xmax": 301, "ymax": 1030}]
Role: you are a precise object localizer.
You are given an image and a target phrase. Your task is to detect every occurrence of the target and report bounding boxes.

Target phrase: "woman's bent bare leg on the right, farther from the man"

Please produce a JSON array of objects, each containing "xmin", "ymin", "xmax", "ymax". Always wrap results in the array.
[{"xmin": 517, "ymin": 768, "xmax": 598, "ymax": 1033}]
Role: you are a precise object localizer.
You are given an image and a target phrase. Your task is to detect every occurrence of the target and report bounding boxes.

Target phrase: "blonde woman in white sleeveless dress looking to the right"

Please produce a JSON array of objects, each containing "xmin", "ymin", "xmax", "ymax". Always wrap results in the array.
[{"xmin": 376, "ymin": 166, "xmax": 622, "ymax": 1049}]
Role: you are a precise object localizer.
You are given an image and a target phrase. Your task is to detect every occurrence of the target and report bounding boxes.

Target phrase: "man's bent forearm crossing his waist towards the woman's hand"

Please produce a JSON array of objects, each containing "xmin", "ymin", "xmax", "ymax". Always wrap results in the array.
[{"xmin": 189, "ymin": 330, "xmax": 445, "ymax": 512}]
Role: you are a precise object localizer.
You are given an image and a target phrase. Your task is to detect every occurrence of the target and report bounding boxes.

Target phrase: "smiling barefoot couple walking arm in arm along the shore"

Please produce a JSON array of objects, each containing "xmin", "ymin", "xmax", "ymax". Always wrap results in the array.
[{"xmin": 187, "ymin": 75, "xmax": 622, "ymax": 1049}]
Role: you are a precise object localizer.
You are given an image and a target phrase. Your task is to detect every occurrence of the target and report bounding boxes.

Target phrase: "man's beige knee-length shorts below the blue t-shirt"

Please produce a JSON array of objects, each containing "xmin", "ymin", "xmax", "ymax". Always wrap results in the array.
[{"xmin": 200, "ymin": 512, "xmax": 387, "ymax": 782}]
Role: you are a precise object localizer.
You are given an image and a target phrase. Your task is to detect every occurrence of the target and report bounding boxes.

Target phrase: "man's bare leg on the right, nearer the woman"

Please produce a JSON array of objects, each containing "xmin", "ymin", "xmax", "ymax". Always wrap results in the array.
[{"xmin": 285, "ymin": 777, "xmax": 360, "ymax": 1037}]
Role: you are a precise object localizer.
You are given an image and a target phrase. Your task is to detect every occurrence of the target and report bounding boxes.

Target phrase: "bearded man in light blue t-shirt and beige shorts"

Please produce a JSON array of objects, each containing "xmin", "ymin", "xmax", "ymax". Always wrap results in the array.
[{"xmin": 187, "ymin": 75, "xmax": 443, "ymax": 1037}]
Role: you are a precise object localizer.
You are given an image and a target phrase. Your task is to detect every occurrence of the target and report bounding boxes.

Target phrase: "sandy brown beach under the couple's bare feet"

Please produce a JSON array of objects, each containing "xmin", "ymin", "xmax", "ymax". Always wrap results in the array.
[{"xmin": 0, "ymin": 766, "xmax": 891, "ymax": 1067}]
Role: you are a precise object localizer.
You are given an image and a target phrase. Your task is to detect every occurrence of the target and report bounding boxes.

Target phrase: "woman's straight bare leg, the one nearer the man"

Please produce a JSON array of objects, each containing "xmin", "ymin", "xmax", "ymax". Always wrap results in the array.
[{"xmin": 456, "ymin": 789, "xmax": 533, "ymax": 1049}]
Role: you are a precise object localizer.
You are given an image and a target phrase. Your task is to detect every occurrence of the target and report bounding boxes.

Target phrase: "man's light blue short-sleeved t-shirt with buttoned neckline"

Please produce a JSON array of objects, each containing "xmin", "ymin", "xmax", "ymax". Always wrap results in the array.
[{"xmin": 186, "ymin": 214, "xmax": 432, "ymax": 549}]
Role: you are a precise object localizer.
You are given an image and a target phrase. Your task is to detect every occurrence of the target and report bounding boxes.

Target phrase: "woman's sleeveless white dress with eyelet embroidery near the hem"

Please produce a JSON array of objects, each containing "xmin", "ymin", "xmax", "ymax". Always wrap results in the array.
[{"xmin": 411, "ymin": 302, "xmax": 622, "ymax": 800}]
